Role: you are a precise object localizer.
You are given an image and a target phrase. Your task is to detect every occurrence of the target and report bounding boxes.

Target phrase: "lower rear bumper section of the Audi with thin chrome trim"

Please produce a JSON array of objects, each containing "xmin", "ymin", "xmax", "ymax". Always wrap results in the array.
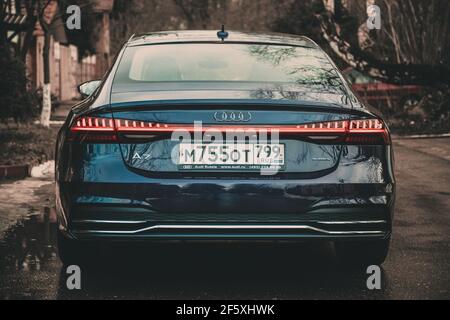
[{"xmin": 60, "ymin": 208, "xmax": 391, "ymax": 241}]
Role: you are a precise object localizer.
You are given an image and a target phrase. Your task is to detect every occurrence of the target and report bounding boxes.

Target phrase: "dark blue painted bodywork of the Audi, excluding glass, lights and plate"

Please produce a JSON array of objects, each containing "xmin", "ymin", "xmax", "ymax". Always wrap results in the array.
[{"xmin": 56, "ymin": 32, "xmax": 395, "ymax": 262}]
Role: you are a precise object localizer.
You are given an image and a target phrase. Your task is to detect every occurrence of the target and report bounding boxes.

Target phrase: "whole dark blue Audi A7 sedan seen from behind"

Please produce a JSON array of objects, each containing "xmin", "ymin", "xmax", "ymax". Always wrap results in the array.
[{"xmin": 56, "ymin": 31, "xmax": 395, "ymax": 264}]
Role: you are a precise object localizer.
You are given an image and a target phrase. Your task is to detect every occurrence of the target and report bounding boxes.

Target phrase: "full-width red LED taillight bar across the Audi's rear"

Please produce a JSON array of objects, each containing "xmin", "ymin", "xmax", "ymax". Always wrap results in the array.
[{"xmin": 71, "ymin": 117, "xmax": 390, "ymax": 144}]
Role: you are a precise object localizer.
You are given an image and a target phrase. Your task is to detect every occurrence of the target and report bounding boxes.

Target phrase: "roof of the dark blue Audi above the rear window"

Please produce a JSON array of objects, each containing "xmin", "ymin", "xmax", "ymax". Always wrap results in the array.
[{"xmin": 127, "ymin": 30, "xmax": 318, "ymax": 48}]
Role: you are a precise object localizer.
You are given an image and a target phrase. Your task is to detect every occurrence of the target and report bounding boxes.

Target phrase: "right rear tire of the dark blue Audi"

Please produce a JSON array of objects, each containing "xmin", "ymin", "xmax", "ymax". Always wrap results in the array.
[{"xmin": 334, "ymin": 239, "xmax": 390, "ymax": 267}]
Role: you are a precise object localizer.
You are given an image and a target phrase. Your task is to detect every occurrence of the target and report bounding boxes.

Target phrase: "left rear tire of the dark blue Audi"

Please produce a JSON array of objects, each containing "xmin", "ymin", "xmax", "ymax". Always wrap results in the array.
[{"xmin": 58, "ymin": 231, "xmax": 97, "ymax": 266}]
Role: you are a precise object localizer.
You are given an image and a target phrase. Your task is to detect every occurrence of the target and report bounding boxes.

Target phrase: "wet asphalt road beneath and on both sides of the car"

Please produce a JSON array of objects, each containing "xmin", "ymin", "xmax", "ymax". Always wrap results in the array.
[{"xmin": 0, "ymin": 139, "xmax": 450, "ymax": 299}]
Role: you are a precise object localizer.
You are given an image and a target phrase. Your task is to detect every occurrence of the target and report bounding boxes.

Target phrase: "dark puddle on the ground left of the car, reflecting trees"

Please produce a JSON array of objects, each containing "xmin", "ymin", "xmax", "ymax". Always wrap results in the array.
[{"xmin": 0, "ymin": 209, "xmax": 61, "ymax": 300}]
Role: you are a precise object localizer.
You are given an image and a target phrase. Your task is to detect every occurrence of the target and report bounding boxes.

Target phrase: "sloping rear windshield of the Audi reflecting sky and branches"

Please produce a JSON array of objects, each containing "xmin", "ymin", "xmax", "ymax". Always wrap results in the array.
[{"xmin": 114, "ymin": 43, "xmax": 341, "ymax": 86}]
